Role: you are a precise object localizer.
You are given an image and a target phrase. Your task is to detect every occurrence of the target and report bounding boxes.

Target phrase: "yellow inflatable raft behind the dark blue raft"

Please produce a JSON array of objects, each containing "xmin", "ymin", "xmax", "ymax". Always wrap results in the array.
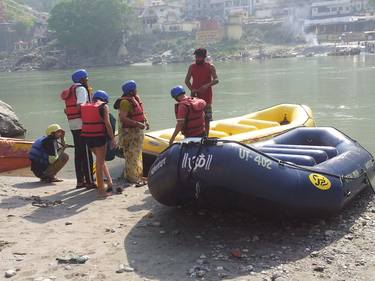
[{"xmin": 143, "ymin": 104, "xmax": 315, "ymax": 172}]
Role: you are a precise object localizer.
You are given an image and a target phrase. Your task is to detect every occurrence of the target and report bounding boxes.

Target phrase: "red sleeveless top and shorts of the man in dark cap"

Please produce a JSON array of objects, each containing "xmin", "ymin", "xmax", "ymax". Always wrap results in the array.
[{"xmin": 191, "ymin": 62, "xmax": 212, "ymax": 104}]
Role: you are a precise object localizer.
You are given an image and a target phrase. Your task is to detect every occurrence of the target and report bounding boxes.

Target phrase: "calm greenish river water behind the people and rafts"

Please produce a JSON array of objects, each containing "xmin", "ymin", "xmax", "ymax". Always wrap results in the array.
[{"xmin": 0, "ymin": 55, "xmax": 375, "ymax": 175}]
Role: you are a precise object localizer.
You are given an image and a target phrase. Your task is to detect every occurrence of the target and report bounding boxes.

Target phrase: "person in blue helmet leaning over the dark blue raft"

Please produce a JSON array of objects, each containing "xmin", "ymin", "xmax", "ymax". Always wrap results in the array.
[{"xmin": 169, "ymin": 86, "xmax": 206, "ymax": 145}]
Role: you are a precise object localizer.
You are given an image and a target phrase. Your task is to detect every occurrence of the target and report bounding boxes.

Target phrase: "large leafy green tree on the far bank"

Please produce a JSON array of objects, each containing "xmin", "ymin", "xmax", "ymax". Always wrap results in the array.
[{"xmin": 48, "ymin": 0, "xmax": 131, "ymax": 56}]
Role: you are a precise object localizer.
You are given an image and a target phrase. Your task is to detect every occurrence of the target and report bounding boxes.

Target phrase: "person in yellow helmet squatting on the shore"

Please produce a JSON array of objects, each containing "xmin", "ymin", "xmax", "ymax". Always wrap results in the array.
[{"xmin": 29, "ymin": 124, "xmax": 69, "ymax": 182}]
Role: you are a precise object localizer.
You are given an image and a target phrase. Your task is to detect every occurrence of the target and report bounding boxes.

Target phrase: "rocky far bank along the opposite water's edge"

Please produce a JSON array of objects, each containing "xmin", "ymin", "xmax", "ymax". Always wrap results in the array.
[{"xmin": 0, "ymin": 44, "xmax": 335, "ymax": 72}]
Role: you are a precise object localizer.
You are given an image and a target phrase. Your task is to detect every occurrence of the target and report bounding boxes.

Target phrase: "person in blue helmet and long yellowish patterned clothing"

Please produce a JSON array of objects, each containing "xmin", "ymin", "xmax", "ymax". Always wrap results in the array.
[{"xmin": 114, "ymin": 80, "xmax": 150, "ymax": 186}]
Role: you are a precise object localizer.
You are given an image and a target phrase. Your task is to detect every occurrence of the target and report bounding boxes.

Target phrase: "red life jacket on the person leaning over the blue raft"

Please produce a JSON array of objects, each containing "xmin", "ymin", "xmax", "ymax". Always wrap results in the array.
[{"xmin": 175, "ymin": 97, "xmax": 206, "ymax": 137}]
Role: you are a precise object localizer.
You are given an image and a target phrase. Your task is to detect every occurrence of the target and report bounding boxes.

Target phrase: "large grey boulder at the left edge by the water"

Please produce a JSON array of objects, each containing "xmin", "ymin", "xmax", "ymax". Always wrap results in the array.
[{"xmin": 0, "ymin": 100, "xmax": 26, "ymax": 137}]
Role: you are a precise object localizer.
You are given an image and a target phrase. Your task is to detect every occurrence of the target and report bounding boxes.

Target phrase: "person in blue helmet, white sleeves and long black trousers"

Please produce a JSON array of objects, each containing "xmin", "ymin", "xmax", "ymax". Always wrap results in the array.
[{"xmin": 61, "ymin": 69, "xmax": 96, "ymax": 189}]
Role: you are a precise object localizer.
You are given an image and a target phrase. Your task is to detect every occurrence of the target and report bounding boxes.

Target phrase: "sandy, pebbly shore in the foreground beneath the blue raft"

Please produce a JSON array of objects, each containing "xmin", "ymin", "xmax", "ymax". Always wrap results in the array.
[{"xmin": 0, "ymin": 176, "xmax": 375, "ymax": 281}]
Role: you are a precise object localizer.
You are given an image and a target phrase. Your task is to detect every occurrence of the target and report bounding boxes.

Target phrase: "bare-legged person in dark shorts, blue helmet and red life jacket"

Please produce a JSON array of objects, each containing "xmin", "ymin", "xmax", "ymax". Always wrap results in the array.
[{"xmin": 81, "ymin": 91, "xmax": 116, "ymax": 198}]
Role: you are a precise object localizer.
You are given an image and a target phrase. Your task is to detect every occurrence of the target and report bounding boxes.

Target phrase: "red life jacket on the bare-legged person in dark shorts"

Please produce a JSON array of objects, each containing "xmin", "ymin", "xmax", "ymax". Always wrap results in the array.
[{"xmin": 81, "ymin": 101, "xmax": 106, "ymax": 137}]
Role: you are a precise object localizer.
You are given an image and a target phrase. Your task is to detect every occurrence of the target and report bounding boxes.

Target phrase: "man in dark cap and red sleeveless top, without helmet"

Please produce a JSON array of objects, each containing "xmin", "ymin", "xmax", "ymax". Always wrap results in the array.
[{"xmin": 185, "ymin": 48, "xmax": 219, "ymax": 136}]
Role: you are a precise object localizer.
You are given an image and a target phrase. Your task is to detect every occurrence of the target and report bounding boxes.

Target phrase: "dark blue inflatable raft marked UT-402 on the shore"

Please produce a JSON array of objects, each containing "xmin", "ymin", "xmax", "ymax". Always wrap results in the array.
[{"xmin": 148, "ymin": 127, "xmax": 375, "ymax": 215}]
